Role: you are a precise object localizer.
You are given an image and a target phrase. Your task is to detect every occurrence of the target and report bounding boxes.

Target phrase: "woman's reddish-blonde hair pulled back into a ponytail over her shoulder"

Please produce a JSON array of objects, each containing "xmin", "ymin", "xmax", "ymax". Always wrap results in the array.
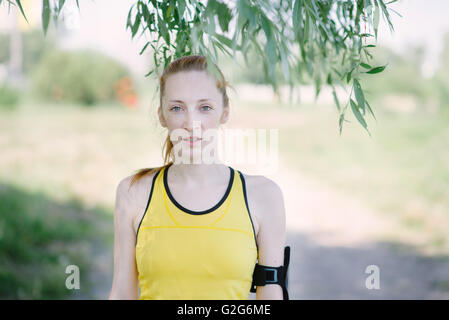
[{"xmin": 130, "ymin": 55, "xmax": 234, "ymax": 187}]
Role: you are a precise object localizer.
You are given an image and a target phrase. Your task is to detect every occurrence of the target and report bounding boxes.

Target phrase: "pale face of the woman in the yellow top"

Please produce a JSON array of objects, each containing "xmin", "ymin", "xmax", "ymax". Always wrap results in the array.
[{"xmin": 158, "ymin": 71, "xmax": 229, "ymax": 159}]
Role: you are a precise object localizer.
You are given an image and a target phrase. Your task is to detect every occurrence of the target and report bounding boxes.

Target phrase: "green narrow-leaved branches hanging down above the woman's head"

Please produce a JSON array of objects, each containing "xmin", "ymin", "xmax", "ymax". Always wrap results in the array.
[{"xmin": 0, "ymin": 0, "xmax": 399, "ymax": 134}]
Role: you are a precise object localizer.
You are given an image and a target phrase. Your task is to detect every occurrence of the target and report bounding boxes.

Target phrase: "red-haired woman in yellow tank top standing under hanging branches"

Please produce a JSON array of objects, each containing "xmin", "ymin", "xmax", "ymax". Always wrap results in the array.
[{"xmin": 109, "ymin": 56, "xmax": 285, "ymax": 300}]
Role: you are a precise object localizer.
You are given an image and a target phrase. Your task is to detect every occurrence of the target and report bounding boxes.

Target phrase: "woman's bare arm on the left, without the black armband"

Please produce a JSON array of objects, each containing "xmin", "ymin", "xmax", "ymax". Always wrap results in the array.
[{"xmin": 109, "ymin": 177, "xmax": 138, "ymax": 300}]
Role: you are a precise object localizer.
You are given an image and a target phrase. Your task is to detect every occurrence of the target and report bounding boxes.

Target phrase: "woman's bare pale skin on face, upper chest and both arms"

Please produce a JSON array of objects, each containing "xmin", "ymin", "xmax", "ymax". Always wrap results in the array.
[{"xmin": 109, "ymin": 71, "xmax": 286, "ymax": 300}]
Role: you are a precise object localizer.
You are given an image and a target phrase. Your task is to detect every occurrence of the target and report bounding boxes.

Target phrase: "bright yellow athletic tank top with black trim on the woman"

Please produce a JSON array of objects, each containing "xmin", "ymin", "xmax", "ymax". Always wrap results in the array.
[{"xmin": 136, "ymin": 165, "xmax": 258, "ymax": 300}]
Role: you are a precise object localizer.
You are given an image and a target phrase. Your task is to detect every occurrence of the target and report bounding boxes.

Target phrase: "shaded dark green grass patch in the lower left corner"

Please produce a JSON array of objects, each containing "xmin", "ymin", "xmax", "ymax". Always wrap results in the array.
[{"xmin": 0, "ymin": 184, "xmax": 111, "ymax": 299}]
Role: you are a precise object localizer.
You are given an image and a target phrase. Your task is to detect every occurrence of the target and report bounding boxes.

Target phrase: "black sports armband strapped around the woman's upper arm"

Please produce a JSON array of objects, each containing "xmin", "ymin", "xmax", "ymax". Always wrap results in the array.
[{"xmin": 250, "ymin": 246, "xmax": 290, "ymax": 300}]
